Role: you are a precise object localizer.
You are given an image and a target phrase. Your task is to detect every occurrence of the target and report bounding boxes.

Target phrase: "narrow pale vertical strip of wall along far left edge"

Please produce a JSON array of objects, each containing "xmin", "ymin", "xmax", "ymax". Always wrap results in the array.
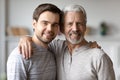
[{"xmin": 0, "ymin": 0, "xmax": 6, "ymax": 80}]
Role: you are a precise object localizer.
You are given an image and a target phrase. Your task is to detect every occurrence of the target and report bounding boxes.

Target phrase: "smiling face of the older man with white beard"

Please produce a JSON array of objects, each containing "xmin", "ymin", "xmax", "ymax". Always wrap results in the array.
[{"xmin": 64, "ymin": 11, "xmax": 86, "ymax": 44}]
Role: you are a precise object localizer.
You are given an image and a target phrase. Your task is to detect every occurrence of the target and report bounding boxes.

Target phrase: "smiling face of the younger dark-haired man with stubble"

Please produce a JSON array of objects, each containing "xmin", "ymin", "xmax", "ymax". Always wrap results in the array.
[{"xmin": 33, "ymin": 11, "xmax": 60, "ymax": 43}]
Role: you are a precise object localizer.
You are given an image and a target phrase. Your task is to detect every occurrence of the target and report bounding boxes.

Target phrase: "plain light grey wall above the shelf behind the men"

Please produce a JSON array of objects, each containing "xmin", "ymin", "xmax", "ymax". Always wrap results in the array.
[{"xmin": 8, "ymin": 0, "xmax": 120, "ymax": 36}]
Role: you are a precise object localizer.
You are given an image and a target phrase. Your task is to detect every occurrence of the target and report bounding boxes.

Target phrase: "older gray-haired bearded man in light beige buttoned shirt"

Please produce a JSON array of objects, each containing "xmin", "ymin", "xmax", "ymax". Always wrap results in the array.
[{"xmin": 18, "ymin": 5, "xmax": 115, "ymax": 80}]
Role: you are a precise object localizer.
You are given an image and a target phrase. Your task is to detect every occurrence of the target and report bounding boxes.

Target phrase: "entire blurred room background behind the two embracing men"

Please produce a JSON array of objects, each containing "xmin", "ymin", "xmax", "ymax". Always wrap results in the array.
[{"xmin": 0, "ymin": 0, "xmax": 120, "ymax": 80}]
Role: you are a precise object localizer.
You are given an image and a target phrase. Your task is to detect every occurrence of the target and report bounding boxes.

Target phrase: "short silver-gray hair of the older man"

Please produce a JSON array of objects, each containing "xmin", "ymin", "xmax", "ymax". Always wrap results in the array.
[{"xmin": 62, "ymin": 5, "xmax": 87, "ymax": 22}]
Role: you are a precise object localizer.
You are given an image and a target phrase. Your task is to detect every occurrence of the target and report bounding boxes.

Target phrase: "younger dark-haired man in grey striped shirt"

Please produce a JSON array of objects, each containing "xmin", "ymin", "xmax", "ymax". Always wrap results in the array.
[{"xmin": 7, "ymin": 3, "xmax": 61, "ymax": 80}]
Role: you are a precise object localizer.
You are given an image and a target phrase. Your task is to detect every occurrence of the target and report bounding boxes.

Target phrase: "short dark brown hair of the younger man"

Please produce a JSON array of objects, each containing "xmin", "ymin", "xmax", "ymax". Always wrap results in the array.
[{"xmin": 33, "ymin": 3, "xmax": 62, "ymax": 24}]
